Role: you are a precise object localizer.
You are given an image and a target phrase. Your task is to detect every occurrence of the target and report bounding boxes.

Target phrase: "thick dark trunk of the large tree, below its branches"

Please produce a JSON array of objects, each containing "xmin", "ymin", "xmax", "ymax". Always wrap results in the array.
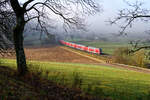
[{"xmin": 13, "ymin": 16, "xmax": 27, "ymax": 75}]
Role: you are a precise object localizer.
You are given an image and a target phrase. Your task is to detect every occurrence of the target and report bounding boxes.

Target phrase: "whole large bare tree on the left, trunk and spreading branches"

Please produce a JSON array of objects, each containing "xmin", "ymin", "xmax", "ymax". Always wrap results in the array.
[{"xmin": 0, "ymin": 0, "xmax": 99, "ymax": 75}]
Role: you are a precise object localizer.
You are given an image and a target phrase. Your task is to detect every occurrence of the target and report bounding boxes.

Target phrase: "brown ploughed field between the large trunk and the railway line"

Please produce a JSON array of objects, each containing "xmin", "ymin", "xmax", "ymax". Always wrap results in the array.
[{"xmin": 25, "ymin": 46, "xmax": 98, "ymax": 63}]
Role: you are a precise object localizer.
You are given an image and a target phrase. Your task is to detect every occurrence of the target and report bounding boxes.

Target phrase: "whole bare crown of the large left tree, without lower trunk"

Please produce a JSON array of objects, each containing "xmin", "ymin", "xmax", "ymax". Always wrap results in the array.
[{"xmin": 0, "ymin": 0, "xmax": 100, "ymax": 49}]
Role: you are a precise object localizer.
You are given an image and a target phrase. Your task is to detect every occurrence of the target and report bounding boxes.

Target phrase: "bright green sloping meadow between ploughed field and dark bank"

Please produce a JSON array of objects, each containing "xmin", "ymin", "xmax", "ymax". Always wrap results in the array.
[{"xmin": 0, "ymin": 59, "xmax": 150, "ymax": 100}]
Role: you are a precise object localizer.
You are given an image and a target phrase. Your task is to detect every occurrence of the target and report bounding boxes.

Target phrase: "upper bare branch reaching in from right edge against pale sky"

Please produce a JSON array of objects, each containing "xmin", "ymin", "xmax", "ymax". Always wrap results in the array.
[{"xmin": 109, "ymin": 1, "xmax": 150, "ymax": 35}]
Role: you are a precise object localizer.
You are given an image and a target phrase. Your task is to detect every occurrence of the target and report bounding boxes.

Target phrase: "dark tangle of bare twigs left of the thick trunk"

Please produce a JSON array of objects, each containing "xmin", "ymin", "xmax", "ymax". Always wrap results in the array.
[{"xmin": 0, "ymin": 0, "xmax": 15, "ymax": 56}]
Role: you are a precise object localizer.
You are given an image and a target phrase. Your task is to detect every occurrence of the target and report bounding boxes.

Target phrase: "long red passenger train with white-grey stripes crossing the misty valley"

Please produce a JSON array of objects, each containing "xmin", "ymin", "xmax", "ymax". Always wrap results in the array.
[{"xmin": 60, "ymin": 40, "xmax": 102, "ymax": 55}]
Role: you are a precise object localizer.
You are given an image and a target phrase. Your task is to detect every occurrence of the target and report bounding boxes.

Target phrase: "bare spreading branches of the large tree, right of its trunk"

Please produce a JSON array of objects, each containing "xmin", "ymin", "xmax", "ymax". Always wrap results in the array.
[{"xmin": 22, "ymin": 0, "xmax": 100, "ymax": 39}]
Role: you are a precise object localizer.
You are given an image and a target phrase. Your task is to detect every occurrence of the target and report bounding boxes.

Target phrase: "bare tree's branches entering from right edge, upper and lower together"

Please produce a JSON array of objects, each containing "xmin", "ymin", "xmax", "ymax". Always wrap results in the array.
[{"xmin": 109, "ymin": 0, "xmax": 150, "ymax": 52}]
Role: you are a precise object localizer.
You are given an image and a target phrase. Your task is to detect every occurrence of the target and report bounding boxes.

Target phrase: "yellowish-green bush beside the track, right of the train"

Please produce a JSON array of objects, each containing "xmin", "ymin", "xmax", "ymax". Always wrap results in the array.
[{"xmin": 113, "ymin": 47, "xmax": 148, "ymax": 67}]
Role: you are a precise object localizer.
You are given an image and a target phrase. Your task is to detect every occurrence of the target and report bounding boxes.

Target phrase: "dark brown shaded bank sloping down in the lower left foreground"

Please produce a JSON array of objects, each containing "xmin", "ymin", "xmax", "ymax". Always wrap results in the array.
[{"xmin": 0, "ymin": 66, "xmax": 100, "ymax": 100}]
